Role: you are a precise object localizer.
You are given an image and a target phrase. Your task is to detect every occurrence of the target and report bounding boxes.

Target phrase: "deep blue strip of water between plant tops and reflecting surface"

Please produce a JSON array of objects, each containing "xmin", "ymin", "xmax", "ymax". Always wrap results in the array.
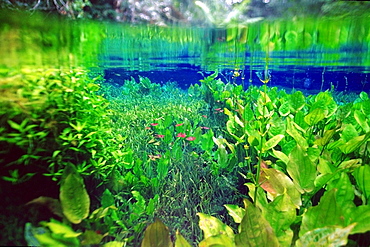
[{"xmin": 104, "ymin": 63, "xmax": 370, "ymax": 93}]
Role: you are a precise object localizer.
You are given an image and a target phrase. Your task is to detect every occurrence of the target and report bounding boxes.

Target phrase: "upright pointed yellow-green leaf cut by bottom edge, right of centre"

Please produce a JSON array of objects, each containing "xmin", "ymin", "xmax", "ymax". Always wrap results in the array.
[{"xmin": 235, "ymin": 199, "xmax": 279, "ymax": 247}]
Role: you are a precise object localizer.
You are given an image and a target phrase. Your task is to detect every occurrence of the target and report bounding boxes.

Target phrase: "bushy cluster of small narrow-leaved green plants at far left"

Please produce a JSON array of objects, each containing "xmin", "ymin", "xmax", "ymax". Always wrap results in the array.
[{"xmin": 0, "ymin": 69, "xmax": 163, "ymax": 246}]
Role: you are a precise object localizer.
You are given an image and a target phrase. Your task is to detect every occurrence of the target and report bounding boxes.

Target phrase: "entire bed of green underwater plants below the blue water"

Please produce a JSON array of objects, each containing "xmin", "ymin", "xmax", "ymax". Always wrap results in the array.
[{"xmin": 0, "ymin": 68, "xmax": 370, "ymax": 246}]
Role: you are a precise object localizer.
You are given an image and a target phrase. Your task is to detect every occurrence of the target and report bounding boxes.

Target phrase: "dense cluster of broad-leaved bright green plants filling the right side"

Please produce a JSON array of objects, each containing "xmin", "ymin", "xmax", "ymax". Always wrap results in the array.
[{"xmin": 165, "ymin": 71, "xmax": 370, "ymax": 246}]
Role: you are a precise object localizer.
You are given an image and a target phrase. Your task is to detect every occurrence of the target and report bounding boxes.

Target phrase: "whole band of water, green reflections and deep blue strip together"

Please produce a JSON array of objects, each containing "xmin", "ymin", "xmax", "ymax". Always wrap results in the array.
[{"xmin": 0, "ymin": 12, "xmax": 370, "ymax": 92}]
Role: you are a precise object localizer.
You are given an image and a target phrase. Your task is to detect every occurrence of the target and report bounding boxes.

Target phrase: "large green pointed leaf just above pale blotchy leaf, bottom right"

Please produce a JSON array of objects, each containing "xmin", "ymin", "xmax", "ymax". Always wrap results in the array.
[{"xmin": 299, "ymin": 189, "xmax": 345, "ymax": 236}]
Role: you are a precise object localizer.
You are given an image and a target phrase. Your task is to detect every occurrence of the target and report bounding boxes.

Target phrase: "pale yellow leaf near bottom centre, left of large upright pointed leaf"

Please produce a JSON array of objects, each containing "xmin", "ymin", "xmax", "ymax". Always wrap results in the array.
[{"xmin": 197, "ymin": 213, "xmax": 234, "ymax": 240}]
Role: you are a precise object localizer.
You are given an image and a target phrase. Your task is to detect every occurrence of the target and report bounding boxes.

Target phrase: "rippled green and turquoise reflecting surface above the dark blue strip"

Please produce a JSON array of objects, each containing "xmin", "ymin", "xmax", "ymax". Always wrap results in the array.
[{"xmin": 0, "ymin": 12, "xmax": 370, "ymax": 73}]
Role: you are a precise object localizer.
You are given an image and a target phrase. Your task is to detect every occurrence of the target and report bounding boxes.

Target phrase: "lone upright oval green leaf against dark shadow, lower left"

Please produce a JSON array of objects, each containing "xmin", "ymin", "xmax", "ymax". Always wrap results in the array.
[{"xmin": 59, "ymin": 165, "xmax": 90, "ymax": 224}]
